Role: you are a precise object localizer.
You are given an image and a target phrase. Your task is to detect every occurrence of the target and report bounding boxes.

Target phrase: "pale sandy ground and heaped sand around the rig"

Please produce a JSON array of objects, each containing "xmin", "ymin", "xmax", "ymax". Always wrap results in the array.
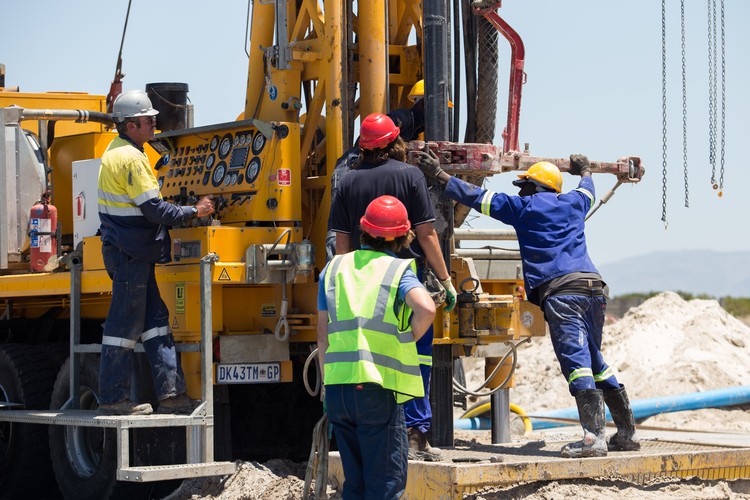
[{"xmin": 168, "ymin": 292, "xmax": 750, "ymax": 500}]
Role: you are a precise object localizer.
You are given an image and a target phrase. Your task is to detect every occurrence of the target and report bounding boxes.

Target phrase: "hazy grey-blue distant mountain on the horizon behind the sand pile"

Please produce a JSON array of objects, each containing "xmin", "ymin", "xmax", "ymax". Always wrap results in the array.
[{"xmin": 597, "ymin": 250, "xmax": 750, "ymax": 298}]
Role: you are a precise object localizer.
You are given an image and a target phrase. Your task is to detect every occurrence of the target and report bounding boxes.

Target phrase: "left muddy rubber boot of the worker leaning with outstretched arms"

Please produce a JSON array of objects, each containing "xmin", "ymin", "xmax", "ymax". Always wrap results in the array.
[{"xmin": 561, "ymin": 389, "xmax": 607, "ymax": 458}]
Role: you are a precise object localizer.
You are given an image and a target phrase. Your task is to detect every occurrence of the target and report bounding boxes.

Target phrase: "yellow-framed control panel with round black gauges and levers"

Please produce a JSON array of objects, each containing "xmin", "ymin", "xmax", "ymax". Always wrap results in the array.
[{"xmin": 151, "ymin": 121, "xmax": 301, "ymax": 223}]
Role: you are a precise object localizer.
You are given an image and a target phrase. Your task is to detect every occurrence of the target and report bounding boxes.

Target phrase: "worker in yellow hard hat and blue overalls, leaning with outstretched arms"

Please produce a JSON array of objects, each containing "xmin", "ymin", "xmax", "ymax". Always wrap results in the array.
[{"xmin": 417, "ymin": 151, "xmax": 640, "ymax": 458}]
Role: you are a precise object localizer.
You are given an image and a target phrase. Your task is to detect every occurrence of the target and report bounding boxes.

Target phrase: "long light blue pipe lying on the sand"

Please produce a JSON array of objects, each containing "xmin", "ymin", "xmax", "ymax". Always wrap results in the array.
[{"xmin": 453, "ymin": 385, "xmax": 750, "ymax": 431}]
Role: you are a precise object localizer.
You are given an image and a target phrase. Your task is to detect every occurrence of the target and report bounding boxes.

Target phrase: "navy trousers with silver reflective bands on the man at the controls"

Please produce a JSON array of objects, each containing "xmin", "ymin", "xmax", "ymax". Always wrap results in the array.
[{"xmin": 99, "ymin": 244, "xmax": 185, "ymax": 404}]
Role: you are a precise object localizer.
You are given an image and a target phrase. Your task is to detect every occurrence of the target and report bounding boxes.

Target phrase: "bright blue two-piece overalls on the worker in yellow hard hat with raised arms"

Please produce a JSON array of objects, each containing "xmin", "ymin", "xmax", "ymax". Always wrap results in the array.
[{"xmin": 445, "ymin": 177, "xmax": 620, "ymax": 395}]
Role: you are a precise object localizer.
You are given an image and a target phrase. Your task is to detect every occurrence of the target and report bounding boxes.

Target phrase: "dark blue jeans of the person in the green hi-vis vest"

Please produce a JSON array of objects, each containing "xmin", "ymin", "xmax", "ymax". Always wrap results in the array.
[{"xmin": 326, "ymin": 384, "xmax": 409, "ymax": 500}]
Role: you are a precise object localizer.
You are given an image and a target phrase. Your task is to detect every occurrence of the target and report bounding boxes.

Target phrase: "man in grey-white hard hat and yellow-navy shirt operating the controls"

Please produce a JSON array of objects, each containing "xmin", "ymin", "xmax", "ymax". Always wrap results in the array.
[{"xmin": 98, "ymin": 90, "xmax": 214, "ymax": 415}]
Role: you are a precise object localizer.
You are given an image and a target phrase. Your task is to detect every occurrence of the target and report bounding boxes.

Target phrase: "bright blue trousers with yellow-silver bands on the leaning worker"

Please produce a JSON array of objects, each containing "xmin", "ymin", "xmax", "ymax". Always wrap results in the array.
[{"xmin": 544, "ymin": 294, "xmax": 620, "ymax": 396}]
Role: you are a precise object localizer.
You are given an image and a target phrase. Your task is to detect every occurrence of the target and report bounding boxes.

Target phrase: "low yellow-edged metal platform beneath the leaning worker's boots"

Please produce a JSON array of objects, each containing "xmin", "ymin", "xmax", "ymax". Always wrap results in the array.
[{"xmin": 329, "ymin": 434, "xmax": 750, "ymax": 500}]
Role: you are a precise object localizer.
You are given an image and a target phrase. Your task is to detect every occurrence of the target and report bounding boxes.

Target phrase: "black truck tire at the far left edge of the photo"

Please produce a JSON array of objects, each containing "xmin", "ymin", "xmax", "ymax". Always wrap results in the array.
[{"xmin": 0, "ymin": 344, "xmax": 56, "ymax": 498}]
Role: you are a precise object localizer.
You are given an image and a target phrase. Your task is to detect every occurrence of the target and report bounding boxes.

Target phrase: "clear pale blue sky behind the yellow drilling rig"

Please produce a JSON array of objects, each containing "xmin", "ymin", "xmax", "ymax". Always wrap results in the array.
[{"xmin": 0, "ymin": 0, "xmax": 750, "ymax": 264}]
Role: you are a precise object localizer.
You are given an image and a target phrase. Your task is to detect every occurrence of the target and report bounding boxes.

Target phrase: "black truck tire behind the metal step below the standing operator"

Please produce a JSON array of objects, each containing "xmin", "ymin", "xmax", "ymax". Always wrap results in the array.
[{"xmin": 49, "ymin": 356, "xmax": 150, "ymax": 500}]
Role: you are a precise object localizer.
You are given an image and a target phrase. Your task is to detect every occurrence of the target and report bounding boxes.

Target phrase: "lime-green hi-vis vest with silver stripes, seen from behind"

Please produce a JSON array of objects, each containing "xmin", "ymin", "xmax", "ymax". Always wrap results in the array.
[{"xmin": 324, "ymin": 250, "xmax": 424, "ymax": 403}]
